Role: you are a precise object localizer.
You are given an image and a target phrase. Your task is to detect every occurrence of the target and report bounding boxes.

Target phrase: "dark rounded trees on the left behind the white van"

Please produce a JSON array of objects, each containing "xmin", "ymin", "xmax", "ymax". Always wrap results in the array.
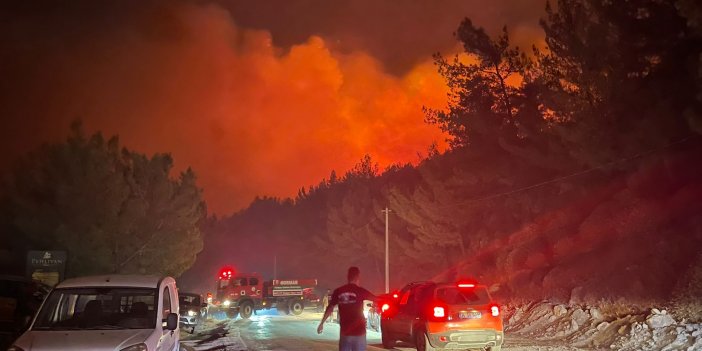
[{"xmin": 0, "ymin": 121, "xmax": 206, "ymax": 277}]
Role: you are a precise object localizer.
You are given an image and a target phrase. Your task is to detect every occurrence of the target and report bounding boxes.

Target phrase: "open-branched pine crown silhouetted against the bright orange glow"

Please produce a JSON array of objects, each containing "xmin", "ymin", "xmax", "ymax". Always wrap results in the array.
[{"xmin": 426, "ymin": 18, "xmax": 529, "ymax": 147}]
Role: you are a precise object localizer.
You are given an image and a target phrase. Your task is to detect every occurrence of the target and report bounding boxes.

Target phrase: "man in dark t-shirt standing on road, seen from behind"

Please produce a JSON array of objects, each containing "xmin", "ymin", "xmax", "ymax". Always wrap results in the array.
[{"xmin": 317, "ymin": 267, "xmax": 377, "ymax": 351}]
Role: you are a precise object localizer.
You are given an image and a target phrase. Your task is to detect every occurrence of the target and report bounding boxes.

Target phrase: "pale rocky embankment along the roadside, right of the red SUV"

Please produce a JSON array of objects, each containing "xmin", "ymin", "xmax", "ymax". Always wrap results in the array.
[{"xmin": 503, "ymin": 301, "xmax": 702, "ymax": 351}]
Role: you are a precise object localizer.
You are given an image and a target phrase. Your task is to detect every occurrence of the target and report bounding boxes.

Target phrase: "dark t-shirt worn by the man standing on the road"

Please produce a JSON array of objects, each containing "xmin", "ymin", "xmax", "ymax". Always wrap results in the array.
[{"xmin": 329, "ymin": 284, "xmax": 376, "ymax": 336}]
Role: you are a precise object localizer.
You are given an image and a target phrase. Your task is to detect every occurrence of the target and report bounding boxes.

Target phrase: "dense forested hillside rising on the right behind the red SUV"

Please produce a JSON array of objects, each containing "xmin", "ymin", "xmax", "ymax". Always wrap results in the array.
[{"xmin": 182, "ymin": 0, "xmax": 702, "ymax": 314}]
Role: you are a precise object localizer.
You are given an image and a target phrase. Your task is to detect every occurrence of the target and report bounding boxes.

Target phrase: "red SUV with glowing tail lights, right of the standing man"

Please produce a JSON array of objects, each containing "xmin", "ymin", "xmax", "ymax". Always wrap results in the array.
[{"xmin": 381, "ymin": 282, "xmax": 504, "ymax": 351}]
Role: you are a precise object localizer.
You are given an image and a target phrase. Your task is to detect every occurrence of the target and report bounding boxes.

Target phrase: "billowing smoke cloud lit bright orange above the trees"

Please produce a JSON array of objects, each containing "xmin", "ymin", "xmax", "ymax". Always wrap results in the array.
[{"xmin": 0, "ymin": 5, "xmax": 446, "ymax": 213}]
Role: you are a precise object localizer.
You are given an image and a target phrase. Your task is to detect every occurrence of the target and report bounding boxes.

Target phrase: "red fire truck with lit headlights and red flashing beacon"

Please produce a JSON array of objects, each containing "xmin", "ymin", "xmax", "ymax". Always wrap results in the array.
[{"xmin": 212, "ymin": 267, "xmax": 320, "ymax": 319}]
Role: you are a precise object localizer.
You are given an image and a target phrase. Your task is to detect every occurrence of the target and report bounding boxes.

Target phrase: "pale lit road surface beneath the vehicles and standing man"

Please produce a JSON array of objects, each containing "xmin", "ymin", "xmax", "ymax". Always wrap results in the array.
[{"xmin": 181, "ymin": 311, "xmax": 582, "ymax": 351}]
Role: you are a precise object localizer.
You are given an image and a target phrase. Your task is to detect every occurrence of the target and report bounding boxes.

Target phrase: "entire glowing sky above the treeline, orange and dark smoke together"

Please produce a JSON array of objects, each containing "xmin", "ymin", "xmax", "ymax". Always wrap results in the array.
[{"xmin": 0, "ymin": 0, "xmax": 545, "ymax": 214}]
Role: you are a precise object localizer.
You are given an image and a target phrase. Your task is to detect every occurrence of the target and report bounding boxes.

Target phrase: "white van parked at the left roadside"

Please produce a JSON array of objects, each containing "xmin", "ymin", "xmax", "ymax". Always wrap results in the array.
[{"xmin": 8, "ymin": 275, "xmax": 180, "ymax": 351}]
